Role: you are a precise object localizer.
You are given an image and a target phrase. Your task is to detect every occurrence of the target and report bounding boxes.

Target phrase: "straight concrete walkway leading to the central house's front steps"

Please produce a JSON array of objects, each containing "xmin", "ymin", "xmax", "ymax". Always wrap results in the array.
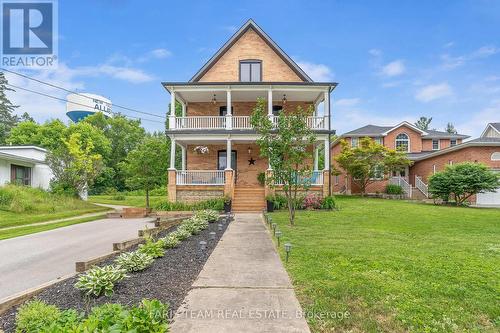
[{"xmin": 171, "ymin": 214, "xmax": 309, "ymax": 333}]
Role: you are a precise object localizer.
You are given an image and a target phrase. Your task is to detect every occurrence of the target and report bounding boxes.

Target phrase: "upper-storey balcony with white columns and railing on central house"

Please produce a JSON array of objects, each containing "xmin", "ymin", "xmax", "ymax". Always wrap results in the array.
[{"xmin": 163, "ymin": 82, "xmax": 335, "ymax": 133}]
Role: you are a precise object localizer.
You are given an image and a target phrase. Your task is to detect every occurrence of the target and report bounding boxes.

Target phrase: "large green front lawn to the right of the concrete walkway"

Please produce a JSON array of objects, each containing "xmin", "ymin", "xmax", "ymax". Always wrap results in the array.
[{"xmin": 271, "ymin": 197, "xmax": 500, "ymax": 332}]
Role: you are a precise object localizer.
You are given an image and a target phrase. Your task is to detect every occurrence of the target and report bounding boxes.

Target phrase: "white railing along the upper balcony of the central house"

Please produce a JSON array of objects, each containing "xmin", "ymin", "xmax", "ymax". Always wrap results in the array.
[{"xmin": 170, "ymin": 116, "xmax": 328, "ymax": 130}]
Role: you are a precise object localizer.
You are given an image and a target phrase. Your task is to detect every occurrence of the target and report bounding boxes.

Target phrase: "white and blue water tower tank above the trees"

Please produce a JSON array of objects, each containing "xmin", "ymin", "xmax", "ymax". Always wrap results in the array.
[{"xmin": 66, "ymin": 93, "xmax": 113, "ymax": 123}]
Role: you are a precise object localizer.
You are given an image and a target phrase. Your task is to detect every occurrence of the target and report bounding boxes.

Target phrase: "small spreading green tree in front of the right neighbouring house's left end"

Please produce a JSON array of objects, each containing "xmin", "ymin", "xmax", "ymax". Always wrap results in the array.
[{"xmin": 335, "ymin": 138, "xmax": 412, "ymax": 195}]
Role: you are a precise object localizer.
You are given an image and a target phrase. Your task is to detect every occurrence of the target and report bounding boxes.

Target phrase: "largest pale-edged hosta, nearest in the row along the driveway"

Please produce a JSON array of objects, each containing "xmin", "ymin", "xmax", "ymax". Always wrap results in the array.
[{"xmin": 75, "ymin": 265, "xmax": 127, "ymax": 297}]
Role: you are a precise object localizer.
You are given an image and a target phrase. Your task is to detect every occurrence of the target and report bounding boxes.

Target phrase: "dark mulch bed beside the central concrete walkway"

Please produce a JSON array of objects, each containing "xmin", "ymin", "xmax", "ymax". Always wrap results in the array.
[{"xmin": 0, "ymin": 217, "xmax": 228, "ymax": 333}]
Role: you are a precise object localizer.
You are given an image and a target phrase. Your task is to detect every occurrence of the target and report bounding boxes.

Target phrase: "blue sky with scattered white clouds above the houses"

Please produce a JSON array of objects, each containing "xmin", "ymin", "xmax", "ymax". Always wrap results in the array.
[{"xmin": 8, "ymin": 0, "xmax": 500, "ymax": 136}]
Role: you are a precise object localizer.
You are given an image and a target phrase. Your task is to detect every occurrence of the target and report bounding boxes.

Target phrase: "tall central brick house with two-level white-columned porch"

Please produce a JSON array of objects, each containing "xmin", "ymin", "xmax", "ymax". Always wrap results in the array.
[{"xmin": 162, "ymin": 20, "xmax": 336, "ymax": 211}]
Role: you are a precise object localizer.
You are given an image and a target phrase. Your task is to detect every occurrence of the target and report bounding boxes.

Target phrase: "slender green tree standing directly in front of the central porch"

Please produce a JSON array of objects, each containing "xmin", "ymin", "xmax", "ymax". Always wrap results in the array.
[{"xmin": 250, "ymin": 98, "xmax": 316, "ymax": 225}]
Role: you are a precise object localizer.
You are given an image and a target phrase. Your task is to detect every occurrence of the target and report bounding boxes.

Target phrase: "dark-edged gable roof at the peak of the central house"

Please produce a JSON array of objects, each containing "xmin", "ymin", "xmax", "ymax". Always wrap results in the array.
[{"xmin": 189, "ymin": 19, "xmax": 313, "ymax": 82}]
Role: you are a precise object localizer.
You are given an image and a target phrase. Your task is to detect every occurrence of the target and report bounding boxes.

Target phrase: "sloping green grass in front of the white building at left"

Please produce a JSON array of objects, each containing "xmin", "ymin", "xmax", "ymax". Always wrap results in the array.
[{"xmin": 0, "ymin": 185, "xmax": 108, "ymax": 229}]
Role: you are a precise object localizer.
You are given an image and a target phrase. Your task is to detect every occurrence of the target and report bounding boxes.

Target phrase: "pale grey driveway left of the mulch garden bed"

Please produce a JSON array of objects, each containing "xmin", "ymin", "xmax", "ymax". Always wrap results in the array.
[{"xmin": 0, "ymin": 218, "xmax": 154, "ymax": 299}]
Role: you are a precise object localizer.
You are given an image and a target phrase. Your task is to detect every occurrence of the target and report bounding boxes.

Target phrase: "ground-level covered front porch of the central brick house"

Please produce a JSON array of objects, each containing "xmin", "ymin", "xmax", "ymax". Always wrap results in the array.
[{"xmin": 168, "ymin": 134, "xmax": 330, "ymax": 201}]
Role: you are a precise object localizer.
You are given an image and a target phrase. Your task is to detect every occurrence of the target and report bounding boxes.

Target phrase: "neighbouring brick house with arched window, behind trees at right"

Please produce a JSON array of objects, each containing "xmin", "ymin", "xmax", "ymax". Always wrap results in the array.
[{"xmin": 332, "ymin": 122, "xmax": 500, "ymax": 205}]
